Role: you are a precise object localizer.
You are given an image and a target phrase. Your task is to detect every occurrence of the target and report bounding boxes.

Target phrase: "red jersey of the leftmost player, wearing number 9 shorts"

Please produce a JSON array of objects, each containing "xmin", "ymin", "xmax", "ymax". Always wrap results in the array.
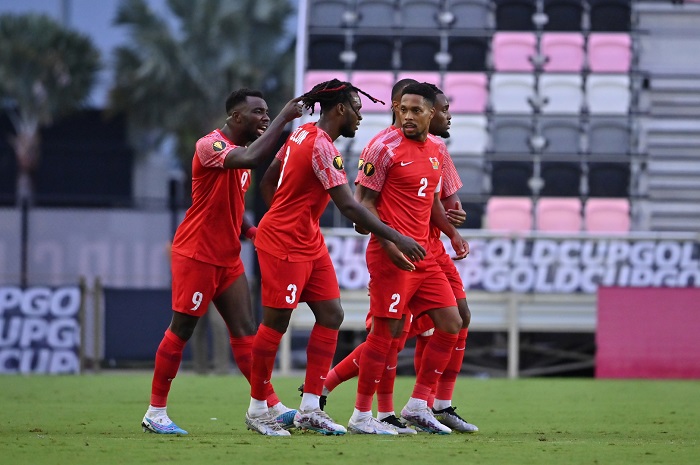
[{"xmin": 172, "ymin": 129, "xmax": 250, "ymax": 266}]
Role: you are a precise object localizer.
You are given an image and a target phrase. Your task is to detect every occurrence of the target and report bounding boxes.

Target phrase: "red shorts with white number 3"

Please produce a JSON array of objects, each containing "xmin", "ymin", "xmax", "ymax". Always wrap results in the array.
[{"xmin": 258, "ymin": 250, "xmax": 340, "ymax": 308}]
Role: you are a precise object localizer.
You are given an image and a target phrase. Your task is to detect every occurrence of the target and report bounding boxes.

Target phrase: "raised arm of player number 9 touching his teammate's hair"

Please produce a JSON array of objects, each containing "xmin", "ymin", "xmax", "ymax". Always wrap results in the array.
[{"xmin": 224, "ymin": 97, "xmax": 302, "ymax": 169}]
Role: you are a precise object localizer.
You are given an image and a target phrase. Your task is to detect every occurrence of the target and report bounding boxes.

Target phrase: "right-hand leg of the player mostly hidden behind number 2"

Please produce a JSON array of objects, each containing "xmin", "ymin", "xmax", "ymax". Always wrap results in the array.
[{"xmin": 432, "ymin": 298, "xmax": 479, "ymax": 433}]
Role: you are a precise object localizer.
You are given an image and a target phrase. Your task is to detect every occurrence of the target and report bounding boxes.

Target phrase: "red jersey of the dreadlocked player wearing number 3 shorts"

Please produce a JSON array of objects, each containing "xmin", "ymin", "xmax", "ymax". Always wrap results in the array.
[{"xmin": 255, "ymin": 123, "xmax": 348, "ymax": 262}]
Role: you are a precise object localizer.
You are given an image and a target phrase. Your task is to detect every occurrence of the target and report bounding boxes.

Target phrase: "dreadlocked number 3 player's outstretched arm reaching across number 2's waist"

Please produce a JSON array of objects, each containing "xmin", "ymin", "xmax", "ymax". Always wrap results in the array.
[{"xmin": 328, "ymin": 183, "xmax": 425, "ymax": 271}]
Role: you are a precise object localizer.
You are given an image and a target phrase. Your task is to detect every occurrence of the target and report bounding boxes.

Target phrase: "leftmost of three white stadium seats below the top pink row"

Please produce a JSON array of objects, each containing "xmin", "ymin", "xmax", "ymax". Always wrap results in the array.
[{"xmin": 490, "ymin": 73, "xmax": 535, "ymax": 114}]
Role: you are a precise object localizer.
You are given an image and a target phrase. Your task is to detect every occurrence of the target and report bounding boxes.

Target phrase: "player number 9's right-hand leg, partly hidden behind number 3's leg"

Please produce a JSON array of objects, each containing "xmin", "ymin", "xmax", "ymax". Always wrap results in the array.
[{"xmin": 214, "ymin": 267, "xmax": 296, "ymax": 428}]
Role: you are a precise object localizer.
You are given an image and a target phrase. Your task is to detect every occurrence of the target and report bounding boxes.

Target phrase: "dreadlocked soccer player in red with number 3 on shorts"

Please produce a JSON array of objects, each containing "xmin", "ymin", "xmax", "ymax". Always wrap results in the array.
[{"xmin": 246, "ymin": 79, "xmax": 425, "ymax": 436}]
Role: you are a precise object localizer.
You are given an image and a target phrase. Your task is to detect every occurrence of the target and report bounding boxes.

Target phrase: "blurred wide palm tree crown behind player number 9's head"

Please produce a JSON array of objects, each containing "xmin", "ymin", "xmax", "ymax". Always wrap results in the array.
[{"xmin": 110, "ymin": 0, "xmax": 293, "ymax": 178}]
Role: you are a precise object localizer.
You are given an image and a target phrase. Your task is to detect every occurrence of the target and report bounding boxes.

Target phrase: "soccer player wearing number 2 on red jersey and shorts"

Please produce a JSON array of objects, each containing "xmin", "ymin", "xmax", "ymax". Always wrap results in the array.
[{"xmin": 348, "ymin": 84, "xmax": 468, "ymax": 434}]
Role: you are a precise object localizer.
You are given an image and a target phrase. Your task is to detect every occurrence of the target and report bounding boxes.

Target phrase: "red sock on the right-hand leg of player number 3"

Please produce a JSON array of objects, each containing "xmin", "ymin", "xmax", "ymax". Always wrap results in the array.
[{"xmin": 304, "ymin": 324, "xmax": 338, "ymax": 396}]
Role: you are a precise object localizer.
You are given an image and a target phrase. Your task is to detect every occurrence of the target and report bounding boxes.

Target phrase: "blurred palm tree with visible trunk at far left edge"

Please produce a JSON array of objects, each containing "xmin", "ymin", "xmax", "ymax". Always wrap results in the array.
[{"xmin": 0, "ymin": 14, "xmax": 100, "ymax": 203}]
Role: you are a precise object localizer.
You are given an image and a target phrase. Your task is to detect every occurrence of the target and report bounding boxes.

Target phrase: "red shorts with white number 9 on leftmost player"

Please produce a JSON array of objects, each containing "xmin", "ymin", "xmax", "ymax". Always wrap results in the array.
[{"xmin": 170, "ymin": 252, "xmax": 245, "ymax": 317}]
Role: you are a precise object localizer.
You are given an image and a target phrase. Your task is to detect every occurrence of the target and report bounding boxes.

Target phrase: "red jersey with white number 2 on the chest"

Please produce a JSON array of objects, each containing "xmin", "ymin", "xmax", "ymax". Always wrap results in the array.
[{"xmin": 356, "ymin": 129, "xmax": 446, "ymax": 254}]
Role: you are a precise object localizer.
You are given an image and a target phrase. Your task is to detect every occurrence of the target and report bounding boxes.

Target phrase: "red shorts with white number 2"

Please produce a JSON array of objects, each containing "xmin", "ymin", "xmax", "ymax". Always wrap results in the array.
[{"xmin": 367, "ymin": 250, "xmax": 457, "ymax": 319}]
